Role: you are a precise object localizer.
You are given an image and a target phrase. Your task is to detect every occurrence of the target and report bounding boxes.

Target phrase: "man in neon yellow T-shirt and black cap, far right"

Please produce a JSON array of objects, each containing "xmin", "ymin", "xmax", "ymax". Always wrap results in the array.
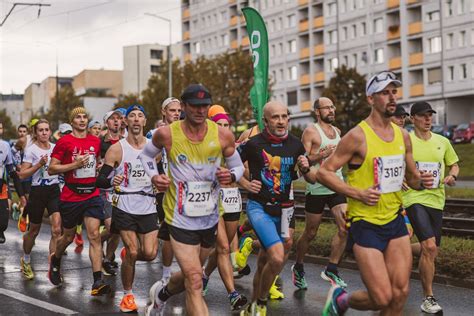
[{"xmin": 403, "ymin": 102, "xmax": 459, "ymax": 314}]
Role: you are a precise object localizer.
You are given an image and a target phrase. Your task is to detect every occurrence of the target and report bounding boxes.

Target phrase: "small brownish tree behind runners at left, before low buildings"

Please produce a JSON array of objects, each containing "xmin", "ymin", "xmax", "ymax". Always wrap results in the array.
[{"xmin": 45, "ymin": 86, "xmax": 82, "ymax": 131}]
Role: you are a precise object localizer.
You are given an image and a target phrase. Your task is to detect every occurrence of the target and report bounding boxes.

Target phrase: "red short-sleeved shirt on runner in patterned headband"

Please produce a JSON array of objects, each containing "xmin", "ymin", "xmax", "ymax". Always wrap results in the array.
[{"xmin": 51, "ymin": 134, "xmax": 100, "ymax": 202}]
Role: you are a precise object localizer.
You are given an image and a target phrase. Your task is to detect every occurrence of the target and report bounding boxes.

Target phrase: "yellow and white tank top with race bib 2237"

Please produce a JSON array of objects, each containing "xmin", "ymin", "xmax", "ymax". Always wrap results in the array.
[{"xmin": 163, "ymin": 120, "xmax": 223, "ymax": 230}]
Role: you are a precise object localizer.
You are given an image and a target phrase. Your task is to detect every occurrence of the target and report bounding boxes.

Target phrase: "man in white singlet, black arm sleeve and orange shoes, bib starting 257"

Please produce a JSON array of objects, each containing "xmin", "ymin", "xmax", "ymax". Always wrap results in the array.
[{"xmin": 97, "ymin": 105, "xmax": 158, "ymax": 313}]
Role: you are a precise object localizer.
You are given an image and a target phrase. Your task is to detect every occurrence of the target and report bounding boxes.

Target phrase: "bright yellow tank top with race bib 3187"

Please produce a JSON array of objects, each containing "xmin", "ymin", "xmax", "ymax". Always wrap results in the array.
[{"xmin": 347, "ymin": 121, "xmax": 405, "ymax": 225}]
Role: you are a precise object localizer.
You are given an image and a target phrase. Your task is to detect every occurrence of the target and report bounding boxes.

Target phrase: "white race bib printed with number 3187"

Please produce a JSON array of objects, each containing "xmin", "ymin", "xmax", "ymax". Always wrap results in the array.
[{"xmin": 374, "ymin": 155, "xmax": 405, "ymax": 193}]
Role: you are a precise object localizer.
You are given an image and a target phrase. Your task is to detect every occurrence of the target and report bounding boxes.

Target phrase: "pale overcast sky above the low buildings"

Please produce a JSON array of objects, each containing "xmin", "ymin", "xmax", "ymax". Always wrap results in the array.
[{"xmin": 0, "ymin": 0, "xmax": 181, "ymax": 94}]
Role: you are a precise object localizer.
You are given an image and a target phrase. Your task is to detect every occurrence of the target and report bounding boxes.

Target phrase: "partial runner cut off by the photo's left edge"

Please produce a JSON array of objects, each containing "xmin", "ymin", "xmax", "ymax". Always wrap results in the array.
[{"xmin": 0, "ymin": 122, "xmax": 26, "ymax": 244}]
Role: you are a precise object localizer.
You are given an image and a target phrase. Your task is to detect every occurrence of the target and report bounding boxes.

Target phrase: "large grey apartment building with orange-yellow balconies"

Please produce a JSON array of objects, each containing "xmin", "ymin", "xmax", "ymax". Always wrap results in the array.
[{"xmin": 182, "ymin": 0, "xmax": 474, "ymax": 124}]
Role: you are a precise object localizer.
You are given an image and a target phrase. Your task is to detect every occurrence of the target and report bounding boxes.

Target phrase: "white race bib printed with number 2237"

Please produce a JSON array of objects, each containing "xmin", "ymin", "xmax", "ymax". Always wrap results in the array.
[{"xmin": 184, "ymin": 181, "xmax": 216, "ymax": 217}]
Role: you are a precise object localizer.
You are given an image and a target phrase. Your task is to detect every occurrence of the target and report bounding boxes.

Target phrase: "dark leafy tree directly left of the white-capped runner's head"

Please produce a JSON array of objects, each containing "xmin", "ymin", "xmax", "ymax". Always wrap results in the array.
[{"xmin": 322, "ymin": 66, "xmax": 370, "ymax": 133}]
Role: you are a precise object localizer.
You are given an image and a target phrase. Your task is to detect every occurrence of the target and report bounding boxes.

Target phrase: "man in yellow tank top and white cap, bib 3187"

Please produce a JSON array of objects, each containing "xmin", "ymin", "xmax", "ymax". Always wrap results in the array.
[{"xmin": 317, "ymin": 72, "xmax": 433, "ymax": 315}]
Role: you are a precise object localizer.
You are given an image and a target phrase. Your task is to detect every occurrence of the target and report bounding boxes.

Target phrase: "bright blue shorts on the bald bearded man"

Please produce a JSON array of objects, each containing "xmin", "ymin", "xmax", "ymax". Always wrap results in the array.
[{"xmin": 247, "ymin": 200, "xmax": 285, "ymax": 249}]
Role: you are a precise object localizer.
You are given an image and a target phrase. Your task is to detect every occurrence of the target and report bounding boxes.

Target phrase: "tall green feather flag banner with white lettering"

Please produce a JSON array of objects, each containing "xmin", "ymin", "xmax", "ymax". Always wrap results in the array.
[{"xmin": 242, "ymin": 7, "xmax": 268, "ymax": 131}]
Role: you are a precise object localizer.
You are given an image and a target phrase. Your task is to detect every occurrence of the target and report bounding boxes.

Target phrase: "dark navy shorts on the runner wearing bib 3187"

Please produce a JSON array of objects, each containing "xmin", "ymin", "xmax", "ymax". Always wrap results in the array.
[{"xmin": 346, "ymin": 214, "xmax": 408, "ymax": 252}]
